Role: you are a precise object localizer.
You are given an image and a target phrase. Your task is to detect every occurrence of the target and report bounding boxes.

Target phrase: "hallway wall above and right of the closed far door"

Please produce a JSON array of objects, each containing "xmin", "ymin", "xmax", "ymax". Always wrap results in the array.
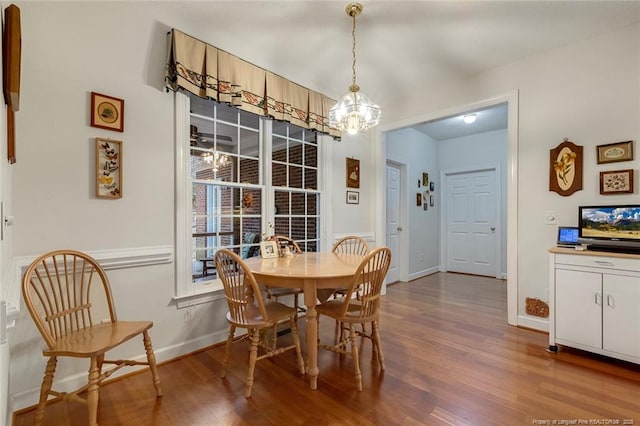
[{"xmin": 438, "ymin": 129, "xmax": 507, "ymax": 277}]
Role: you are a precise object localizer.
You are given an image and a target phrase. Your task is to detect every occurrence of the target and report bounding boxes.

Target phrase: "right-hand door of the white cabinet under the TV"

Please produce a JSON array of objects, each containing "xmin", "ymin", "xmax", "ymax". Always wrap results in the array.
[{"xmin": 602, "ymin": 274, "xmax": 640, "ymax": 357}]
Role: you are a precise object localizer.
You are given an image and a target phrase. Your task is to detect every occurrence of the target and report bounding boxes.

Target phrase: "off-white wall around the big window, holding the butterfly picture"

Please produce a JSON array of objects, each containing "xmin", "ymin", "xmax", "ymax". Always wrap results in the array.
[{"xmin": 7, "ymin": 1, "xmax": 375, "ymax": 409}]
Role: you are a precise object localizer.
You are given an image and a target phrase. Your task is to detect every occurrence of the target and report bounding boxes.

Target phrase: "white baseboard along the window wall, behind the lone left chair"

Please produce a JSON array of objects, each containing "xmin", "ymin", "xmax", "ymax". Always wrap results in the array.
[{"xmin": 12, "ymin": 329, "xmax": 229, "ymax": 411}]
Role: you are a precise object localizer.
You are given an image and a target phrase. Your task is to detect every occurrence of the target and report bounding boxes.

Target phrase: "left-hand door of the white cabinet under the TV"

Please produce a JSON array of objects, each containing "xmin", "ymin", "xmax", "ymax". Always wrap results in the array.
[{"xmin": 555, "ymin": 269, "xmax": 602, "ymax": 349}]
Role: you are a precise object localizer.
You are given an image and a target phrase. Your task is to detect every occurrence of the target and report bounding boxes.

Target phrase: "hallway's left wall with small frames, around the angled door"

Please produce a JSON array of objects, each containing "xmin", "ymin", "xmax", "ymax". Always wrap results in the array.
[{"xmin": 387, "ymin": 128, "xmax": 440, "ymax": 279}]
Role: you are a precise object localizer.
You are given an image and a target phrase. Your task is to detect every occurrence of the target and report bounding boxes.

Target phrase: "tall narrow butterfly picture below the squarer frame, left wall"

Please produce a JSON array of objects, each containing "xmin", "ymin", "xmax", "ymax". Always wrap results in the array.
[{"xmin": 96, "ymin": 138, "xmax": 122, "ymax": 198}]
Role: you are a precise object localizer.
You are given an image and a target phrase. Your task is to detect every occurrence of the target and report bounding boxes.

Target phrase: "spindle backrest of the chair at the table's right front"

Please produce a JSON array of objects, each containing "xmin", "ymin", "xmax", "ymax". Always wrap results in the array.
[{"xmin": 341, "ymin": 247, "xmax": 391, "ymax": 322}]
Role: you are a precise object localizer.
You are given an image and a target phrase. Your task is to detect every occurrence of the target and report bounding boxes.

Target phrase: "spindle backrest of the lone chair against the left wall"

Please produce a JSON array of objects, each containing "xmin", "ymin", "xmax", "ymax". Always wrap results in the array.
[{"xmin": 22, "ymin": 250, "xmax": 117, "ymax": 348}]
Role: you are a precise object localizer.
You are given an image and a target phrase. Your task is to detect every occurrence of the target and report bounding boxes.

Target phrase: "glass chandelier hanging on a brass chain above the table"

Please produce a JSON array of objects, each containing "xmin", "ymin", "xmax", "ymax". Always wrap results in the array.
[{"xmin": 329, "ymin": 3, "xmax": 382, "ymax": 135}]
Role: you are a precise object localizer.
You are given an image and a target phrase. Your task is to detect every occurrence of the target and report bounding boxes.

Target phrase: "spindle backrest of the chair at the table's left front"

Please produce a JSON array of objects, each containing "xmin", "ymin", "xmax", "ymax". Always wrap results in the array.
[{"xmin": 214, "ymin": 249, "xmax": 269, "ymax": 325}]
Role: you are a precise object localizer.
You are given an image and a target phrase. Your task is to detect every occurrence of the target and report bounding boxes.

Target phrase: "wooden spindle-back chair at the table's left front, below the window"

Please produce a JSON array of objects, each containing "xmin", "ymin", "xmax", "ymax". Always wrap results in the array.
[{"xmin": 214, "ymin": 249, "xmax": 305, "ymax": 398}]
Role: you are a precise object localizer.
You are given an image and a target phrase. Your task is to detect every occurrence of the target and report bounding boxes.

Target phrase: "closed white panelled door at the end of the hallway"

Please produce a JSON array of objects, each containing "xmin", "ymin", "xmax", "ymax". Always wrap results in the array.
[{"xmin": 445, "ymin": 169, "xmax": 498, "ymax": 277}]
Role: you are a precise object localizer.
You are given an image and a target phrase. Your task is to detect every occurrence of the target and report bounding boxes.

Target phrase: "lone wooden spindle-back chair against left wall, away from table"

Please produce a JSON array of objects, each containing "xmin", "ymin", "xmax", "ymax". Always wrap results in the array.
[{"xmin": 22, "ymin": 250, "xmax": 162, "ymax": 425}]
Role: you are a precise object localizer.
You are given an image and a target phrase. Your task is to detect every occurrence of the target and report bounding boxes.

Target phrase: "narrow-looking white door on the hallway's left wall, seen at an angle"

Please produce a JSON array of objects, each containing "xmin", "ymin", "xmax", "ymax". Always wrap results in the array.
[{"xmin": 386, "ymin": 164, "xmax": 401, "ymax": 283}]
